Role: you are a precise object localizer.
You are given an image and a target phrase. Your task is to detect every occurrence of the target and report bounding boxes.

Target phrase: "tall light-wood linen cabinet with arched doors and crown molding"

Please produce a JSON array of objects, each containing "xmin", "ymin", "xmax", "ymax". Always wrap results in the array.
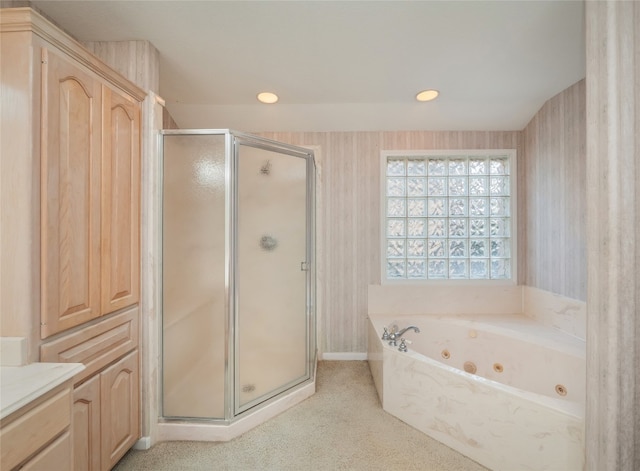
[{"xmin": 0, "ymin": 8, "xmax": 145, "ymax": 470}]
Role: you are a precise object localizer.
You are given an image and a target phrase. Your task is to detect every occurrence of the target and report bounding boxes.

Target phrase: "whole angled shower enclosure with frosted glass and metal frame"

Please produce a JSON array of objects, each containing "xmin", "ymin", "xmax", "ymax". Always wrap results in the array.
[{"xmin": 160, "ymin": 130, "xmax": 316, "ymax": 423}]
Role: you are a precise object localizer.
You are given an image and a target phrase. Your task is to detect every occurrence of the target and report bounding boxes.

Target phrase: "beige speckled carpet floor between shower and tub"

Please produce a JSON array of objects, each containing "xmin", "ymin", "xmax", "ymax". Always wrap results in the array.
[{"xmin": 114, "ymin": 361, "xmax": 486, "ymax": 471}]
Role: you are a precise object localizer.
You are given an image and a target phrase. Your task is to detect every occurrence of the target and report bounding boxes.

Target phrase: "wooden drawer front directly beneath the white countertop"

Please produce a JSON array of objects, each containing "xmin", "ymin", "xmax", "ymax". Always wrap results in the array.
[{"xmin": 0, "ymin": 387, "xmax": 71, "ymax": 470}]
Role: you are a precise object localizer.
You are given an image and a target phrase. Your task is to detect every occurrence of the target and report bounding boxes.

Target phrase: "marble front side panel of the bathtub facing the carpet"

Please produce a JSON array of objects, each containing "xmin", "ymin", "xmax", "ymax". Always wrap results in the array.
[{"xmin": 383, "ymin": 342, "xmax": 584, "ymax": 471}]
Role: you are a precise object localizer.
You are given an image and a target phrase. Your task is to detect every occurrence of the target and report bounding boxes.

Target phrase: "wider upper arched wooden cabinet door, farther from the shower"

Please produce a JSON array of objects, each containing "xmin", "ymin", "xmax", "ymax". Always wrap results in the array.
[{"xmin": 41, "ymin": 49, "xmax": 102, "ymax": 338}]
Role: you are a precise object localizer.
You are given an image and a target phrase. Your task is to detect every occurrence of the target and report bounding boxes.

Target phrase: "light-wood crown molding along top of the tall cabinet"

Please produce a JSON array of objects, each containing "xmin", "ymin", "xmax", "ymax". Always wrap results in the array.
[{"xmin": 0, "ymin": 8, "xmax": 147, "ymax": 102}]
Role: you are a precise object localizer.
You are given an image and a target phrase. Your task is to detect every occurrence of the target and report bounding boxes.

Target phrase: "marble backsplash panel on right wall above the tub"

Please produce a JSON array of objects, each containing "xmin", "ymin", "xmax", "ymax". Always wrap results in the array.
[{"xmin": 523, "ymin": 286, "xmax": 587, "ymax": 340}]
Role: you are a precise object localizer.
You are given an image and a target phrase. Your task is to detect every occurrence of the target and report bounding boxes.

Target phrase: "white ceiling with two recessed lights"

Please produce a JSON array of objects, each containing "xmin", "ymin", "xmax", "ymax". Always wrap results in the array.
[{"xmin": 27, "ymin": 0, "xmax": 585, "ymax": 131}]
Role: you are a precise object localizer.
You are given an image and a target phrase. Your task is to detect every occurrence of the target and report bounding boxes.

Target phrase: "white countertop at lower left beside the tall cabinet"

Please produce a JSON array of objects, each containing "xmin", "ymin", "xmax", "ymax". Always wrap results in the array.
[{"xmin": 0, "ymin": 363, "xmax": 85, "ymax": 419}]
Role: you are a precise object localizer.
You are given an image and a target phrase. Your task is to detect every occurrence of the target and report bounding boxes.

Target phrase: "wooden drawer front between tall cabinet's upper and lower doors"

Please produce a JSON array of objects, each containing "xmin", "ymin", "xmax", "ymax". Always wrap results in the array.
[{"xmin": 40, "ymin": 306, "xmax": 139, "ymax": 384}]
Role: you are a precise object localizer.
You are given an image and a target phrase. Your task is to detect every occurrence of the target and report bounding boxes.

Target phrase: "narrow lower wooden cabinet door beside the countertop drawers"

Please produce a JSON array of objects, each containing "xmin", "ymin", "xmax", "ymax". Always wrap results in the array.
[{"xmin": 73, "ymin": 375, "xmax": 100, "ymax": 471}]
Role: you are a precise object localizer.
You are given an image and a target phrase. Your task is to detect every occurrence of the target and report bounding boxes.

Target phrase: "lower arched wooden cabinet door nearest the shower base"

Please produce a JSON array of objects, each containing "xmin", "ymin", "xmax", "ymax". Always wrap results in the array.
[{"xmin": 100, "ymin": 350, "xmax": 140, "ymax": 469}]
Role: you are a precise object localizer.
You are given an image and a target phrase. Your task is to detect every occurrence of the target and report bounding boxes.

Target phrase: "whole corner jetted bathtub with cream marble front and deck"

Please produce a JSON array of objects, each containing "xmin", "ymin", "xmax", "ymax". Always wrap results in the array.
[{"xmin": 368, "ymin": 315, "xmax": 585, "ymax": 471}]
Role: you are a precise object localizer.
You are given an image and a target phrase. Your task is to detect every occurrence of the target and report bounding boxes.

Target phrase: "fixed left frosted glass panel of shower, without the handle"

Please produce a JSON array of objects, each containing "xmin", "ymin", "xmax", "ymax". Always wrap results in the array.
[{"xmin": 162, "ymin": 134, "xmax": 228, "ymax": 419}]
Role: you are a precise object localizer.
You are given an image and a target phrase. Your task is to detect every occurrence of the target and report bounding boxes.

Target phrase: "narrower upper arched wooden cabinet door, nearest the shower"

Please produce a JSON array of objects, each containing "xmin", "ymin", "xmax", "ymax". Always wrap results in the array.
[{"xmin": 101, "ymin": 86, "xmax": 141, "ymax": 314}]
